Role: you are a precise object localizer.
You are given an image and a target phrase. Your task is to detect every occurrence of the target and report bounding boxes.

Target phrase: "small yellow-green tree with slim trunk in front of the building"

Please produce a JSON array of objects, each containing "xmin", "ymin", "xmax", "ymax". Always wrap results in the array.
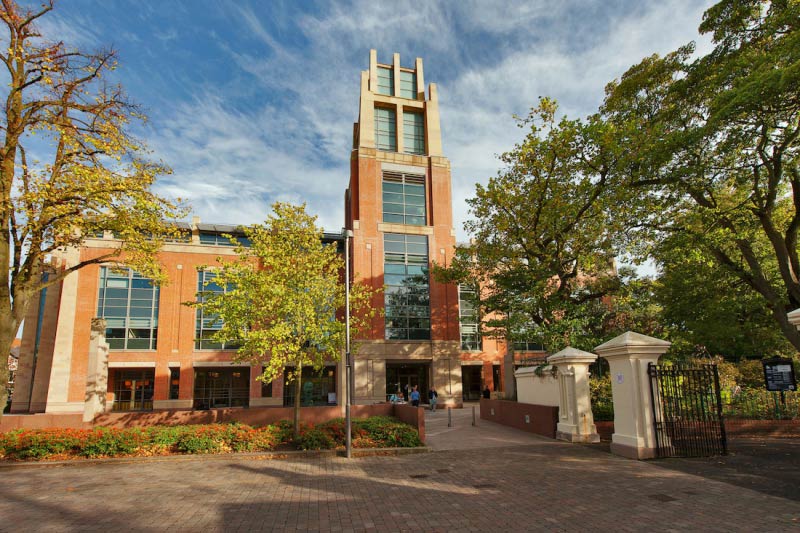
[{"xmin": 195, "ymin": 203, "xmax": 375, "ymax": 437}]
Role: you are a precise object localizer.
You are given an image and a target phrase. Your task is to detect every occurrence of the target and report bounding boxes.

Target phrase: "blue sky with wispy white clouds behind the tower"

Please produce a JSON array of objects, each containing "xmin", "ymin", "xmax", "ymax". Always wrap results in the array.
[{"xmin": 34, "ymin": 0, "xmax": 711, "ymax": 240}]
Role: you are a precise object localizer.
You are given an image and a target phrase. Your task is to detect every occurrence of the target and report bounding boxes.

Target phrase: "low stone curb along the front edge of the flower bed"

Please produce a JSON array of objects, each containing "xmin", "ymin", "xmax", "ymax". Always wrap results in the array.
[{"xmin": 0, "ymin": 446, "xmax": 433, "ymax": 470}]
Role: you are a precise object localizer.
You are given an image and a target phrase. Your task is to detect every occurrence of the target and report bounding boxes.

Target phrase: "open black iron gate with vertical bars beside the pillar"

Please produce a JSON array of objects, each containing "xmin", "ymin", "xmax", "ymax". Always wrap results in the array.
[{"xmin": 648, "ymin": 363, "xmax": 728, "ymax": 457}]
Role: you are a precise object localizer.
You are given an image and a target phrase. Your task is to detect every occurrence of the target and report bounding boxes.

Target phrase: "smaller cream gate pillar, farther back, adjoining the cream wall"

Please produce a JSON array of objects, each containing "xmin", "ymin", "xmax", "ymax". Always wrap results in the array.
[{"xmin": 547, "ymin": 347, "xmax": 600, "ymax": 442}]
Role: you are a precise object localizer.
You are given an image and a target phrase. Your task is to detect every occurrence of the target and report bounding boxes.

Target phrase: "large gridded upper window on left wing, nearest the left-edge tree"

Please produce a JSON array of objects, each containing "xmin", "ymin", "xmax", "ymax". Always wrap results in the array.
[{"xmin": 97, "ymin": 267, "xmax": 159, "ymax": 350}]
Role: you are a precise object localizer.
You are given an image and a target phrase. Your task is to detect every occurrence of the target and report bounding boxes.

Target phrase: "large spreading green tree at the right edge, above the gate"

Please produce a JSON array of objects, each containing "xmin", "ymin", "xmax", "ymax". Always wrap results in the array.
[{"xmin": 602, "ymin": 0, "xmax": 800, "ymax": 349}]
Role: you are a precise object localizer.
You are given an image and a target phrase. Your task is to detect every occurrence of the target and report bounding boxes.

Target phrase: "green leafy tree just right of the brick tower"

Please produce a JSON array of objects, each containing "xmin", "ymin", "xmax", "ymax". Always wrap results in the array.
[{"xmin": 435, "ymin": 99, "xmax": 625, "ymax": 351}]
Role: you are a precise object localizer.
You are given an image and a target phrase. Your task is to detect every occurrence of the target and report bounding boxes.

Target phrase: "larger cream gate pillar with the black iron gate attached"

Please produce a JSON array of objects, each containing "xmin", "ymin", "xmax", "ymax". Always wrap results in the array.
[{"xmin": 594, "ymin": 331, "xmax": 670, "ymax": 459}]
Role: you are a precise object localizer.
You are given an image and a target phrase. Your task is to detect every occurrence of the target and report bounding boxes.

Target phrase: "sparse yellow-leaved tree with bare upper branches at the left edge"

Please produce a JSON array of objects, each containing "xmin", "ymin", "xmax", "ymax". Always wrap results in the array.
[{"xmin": 0, "ymin": 0, "xmax": 182, "ymax": 412}]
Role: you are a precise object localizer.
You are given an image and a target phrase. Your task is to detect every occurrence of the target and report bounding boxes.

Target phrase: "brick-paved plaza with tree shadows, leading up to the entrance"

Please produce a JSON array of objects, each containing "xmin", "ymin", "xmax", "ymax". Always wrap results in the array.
[{"xmin": 0, "ymin": 408, "xmax": 800, "ymax": 532}]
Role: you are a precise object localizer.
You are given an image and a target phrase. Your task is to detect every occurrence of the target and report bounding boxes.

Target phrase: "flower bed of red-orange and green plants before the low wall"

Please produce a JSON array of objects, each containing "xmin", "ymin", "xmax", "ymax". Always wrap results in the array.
[{"xmin": 0, "ymin": 417, "xmax": 422, "ymax": 460}]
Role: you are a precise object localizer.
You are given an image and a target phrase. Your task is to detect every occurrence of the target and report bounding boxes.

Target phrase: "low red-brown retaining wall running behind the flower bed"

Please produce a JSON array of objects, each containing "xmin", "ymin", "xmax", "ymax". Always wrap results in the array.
[{"xmin": 0, "ymin": 403, "xmax": 425, "ymax": 442}]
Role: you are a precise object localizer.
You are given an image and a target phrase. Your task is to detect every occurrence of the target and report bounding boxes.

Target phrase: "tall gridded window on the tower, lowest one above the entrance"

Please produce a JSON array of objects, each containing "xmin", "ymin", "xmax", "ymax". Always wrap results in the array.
[{"xmin": 383, "ymin": 233, "xmax": 431, "ymax": 340}]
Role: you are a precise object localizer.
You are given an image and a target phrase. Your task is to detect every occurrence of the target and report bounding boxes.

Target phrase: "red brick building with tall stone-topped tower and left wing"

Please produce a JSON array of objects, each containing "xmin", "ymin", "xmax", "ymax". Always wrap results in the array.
[{"xmin": 11, "ymin": 50, "xmax": 536, "ymax": 413}]
